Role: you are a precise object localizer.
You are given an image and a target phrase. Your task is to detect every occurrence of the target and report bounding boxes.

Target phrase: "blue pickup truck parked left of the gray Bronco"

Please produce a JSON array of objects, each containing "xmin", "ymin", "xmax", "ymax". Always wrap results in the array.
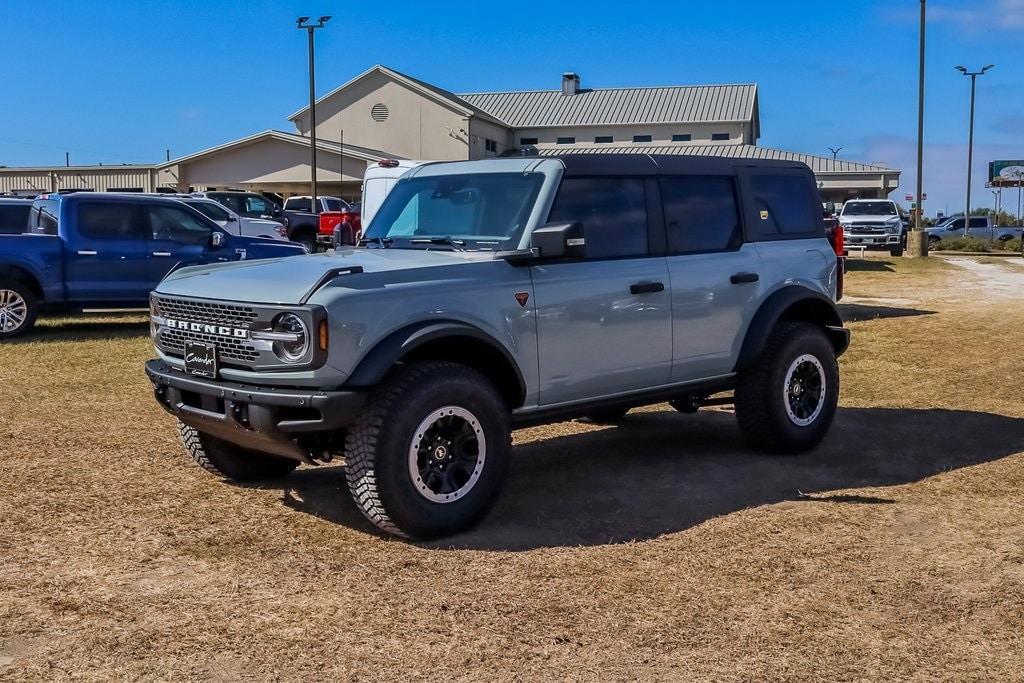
[{"xmin": 0, "ymin": 193, "xmax": 306, "ymax": 341}]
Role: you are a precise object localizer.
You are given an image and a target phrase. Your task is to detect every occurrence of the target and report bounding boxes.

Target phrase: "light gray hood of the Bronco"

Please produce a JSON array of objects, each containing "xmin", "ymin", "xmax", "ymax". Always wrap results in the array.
[{"xmin": 156, "ymin": 249, "xmax": 493, "ymax": 304}]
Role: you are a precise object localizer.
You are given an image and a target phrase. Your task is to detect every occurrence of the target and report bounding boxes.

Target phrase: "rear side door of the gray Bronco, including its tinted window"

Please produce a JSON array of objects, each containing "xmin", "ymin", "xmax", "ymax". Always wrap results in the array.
[{"xmin": 659, "ymin": 175, "xmax": 764, "ymax": 382}]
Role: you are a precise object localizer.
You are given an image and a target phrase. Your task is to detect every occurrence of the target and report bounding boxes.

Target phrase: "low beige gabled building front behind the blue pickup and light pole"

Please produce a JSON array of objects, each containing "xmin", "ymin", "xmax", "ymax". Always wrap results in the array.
[{"xmin": 157, "ymin": 130, "xmax": 395, "ymax": 200}]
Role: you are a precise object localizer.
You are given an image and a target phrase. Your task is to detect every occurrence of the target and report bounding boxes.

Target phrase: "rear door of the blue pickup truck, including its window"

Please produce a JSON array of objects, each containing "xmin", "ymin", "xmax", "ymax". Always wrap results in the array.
[{"xmin": 60, "ymin": 200, "xmax": 150, "ymax": 303}]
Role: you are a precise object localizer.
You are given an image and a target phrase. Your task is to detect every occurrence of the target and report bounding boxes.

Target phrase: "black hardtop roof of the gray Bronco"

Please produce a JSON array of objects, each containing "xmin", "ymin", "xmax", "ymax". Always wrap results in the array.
[{"xmin": 549, "ymin": 154, "xmax": 811, "ymax": 176}]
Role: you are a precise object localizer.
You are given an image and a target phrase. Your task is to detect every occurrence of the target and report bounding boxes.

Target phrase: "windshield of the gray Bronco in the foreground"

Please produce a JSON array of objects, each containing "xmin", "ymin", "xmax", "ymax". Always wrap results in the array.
[{"xmin": 366, "ymin": 173, "xmax": 544, "ymax": 251}]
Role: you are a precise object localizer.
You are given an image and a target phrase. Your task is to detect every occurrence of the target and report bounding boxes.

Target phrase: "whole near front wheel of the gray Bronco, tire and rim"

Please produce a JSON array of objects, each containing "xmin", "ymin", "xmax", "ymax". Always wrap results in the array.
[{"xmin": 345, "ymin": 361, "xmax": 511, "ymax": 539}]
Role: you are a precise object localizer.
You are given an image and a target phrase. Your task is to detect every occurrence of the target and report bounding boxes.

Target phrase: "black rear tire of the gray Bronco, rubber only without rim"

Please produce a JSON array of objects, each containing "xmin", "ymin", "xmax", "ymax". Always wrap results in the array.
[{"xmin": 735, "ymin": 323, "xmax": 839, "ymax": 455}]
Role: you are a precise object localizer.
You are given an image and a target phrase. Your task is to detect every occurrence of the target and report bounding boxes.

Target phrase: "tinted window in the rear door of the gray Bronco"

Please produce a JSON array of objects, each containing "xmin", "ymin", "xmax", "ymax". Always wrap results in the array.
[{"xmin": 662, "ymin": 175, "xmax": 740, "ymax": 253}]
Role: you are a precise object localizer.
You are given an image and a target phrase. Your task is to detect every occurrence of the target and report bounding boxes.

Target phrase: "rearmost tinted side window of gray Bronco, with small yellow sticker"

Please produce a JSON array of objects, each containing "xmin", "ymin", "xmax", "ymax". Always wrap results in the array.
[{"xmin": 751, "ymin": 173, "xmax": 821, "ymax": 237}]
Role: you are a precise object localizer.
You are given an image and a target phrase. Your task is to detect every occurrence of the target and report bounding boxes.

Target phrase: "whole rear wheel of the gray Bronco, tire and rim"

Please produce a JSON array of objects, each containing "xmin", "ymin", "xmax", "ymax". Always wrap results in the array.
[{"xmin": 735, "ymin": 323, "xmax": 839, "ymax": 454}]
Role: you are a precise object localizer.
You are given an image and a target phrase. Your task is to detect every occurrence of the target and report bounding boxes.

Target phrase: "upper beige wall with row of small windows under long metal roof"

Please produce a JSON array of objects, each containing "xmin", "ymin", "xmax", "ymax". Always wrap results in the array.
[{"xmin": 514, "ymin": 123, "xmax": 755, "ymax": 146}]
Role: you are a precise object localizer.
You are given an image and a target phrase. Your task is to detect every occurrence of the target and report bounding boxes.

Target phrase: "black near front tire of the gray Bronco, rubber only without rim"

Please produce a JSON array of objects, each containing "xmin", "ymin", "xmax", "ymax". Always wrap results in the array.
[{"xmin": 345, "ymin": 360, "xmax": 512, "ymax": 540}]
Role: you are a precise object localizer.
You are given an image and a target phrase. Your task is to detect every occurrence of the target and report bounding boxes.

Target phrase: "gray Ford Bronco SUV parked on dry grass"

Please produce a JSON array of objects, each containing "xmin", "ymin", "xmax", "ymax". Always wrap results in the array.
[{"xmin": 146, "ymin": 155, "xmax": 849, "ymax": 539}]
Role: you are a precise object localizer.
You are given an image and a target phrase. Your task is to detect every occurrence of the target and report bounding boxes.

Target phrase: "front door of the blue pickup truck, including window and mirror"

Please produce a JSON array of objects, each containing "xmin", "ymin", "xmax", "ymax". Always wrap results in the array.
[{"xmin": 142, "ymin": 204, "xmax": 229, "ymax": 290}]
